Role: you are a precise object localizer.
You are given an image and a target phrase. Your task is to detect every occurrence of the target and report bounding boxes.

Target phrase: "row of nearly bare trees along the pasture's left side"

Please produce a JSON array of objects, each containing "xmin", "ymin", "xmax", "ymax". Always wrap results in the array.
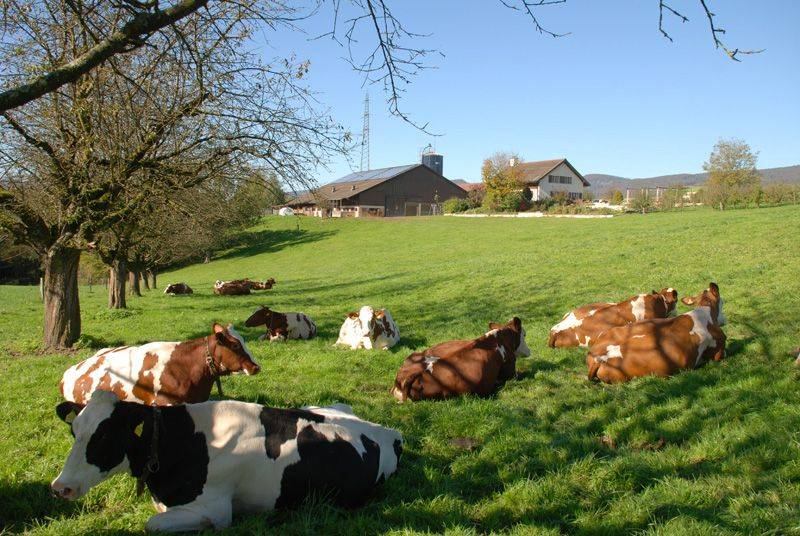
[{"xmin": 0, "ymin": 0, "xmax": 340, "ymax": 348}]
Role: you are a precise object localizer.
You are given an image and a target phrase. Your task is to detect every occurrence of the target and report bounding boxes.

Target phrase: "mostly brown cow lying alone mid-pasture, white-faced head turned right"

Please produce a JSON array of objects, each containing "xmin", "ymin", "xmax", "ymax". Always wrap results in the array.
[{"xmin": 392, "ymin": 317, "xmax": 531, "ymax": 402}]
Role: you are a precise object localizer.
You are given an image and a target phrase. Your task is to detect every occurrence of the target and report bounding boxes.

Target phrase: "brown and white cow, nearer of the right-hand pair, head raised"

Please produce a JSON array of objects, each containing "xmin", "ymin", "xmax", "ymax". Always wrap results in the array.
[{"xmin": 586, "ymin": 283, "xmax": 726, "ymax": 383}]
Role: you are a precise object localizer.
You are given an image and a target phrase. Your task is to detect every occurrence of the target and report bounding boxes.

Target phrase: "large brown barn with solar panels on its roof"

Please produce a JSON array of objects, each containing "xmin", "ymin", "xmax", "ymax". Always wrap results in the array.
[{"xmin": 287, "ymin": 160, "xmax": 467, "ymax": 218}]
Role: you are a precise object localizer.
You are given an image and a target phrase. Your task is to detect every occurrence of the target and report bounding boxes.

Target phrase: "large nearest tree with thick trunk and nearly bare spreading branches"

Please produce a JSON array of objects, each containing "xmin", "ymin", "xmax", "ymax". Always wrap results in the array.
[{"xmin": 0, "ymin": 0, "xmax": 349, "ymax": 348}]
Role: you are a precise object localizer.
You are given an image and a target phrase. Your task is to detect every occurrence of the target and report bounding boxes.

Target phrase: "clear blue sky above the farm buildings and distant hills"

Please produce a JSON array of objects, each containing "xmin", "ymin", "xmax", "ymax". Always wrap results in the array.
[{"xmin": 257, "ymin": 0, "xmax": 800, "ymax": 183}]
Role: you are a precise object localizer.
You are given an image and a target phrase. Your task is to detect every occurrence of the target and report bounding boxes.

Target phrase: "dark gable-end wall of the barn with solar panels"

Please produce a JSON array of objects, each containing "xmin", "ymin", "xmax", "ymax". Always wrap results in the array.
[{"xmin": 357, "ymin": 166, "xmax": 467, "ymax": 216}]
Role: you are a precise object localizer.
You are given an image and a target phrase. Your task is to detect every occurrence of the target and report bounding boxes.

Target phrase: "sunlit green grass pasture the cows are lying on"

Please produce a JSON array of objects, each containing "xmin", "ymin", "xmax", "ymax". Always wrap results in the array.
[{"xmin": 0, "ymin": 206, "xmax": 800, "ymax": 535}]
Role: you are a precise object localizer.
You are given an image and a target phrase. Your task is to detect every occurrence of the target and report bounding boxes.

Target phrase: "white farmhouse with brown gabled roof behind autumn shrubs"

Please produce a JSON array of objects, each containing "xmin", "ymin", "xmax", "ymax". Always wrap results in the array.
[{"xmin": 511, "ymin": 158, "xmax": 590, "ymax": 201}]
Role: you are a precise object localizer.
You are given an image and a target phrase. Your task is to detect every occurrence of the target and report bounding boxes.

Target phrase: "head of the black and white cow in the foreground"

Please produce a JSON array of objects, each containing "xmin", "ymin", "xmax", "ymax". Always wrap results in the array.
[{"xmin": 50, "ymin": 390, "xmax": 138, "ymax": 501}]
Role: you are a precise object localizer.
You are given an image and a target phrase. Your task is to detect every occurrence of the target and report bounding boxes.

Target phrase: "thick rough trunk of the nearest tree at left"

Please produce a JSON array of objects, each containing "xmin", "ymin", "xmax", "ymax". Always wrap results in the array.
[{"xmin": 42, "ymin": 248, "xmax": 81, "ymax": 349}]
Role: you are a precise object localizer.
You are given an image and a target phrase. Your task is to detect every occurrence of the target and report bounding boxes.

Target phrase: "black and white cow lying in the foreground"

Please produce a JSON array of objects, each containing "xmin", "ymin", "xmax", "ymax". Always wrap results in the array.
[{"xmin": 51, "ymin": 391, "xmax": 403, "ymax": 532}]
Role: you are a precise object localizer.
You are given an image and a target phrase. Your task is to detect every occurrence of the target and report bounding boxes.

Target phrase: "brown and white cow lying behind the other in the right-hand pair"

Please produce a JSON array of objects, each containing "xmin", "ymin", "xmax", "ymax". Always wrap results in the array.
[{"xmin": 547, "ymin": 288, "xmax": 678, "ymax": 348}]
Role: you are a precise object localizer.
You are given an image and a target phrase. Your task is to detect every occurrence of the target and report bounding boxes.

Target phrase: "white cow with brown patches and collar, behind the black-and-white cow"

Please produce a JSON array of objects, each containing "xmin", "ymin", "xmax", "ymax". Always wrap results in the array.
[{"xmin": 60, "ymin": 324, "xmax": 260, "ymax": 405}]
